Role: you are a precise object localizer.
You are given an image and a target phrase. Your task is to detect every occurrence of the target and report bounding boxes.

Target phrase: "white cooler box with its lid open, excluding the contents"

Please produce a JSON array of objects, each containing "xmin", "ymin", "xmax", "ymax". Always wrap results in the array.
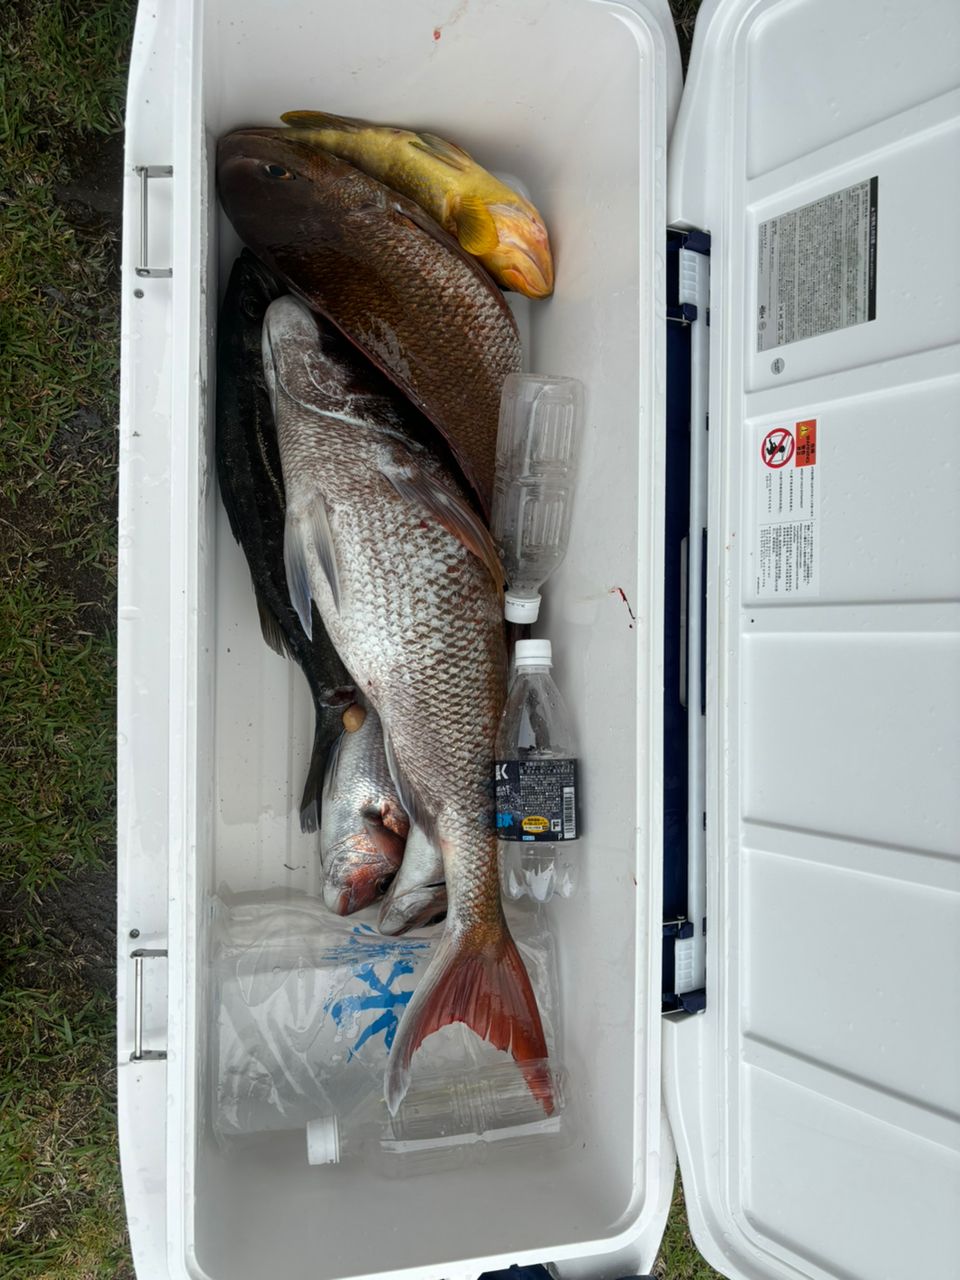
[{"xmin": 118, "ymin": 0, "xmax": 960, "ymax": 1280}]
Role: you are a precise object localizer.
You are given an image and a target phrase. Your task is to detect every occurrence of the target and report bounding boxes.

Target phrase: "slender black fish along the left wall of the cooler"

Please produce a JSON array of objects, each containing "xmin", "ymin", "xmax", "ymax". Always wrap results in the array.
[{"xmin": 216, "ymin": 250, "xmax": 353, "ymax": 831}]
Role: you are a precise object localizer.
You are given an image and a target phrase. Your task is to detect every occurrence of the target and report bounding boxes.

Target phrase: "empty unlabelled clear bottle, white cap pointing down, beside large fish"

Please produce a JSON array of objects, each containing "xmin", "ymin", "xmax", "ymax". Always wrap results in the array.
[{"xmin": 490, "ymin": 374, "xmax": 584, "ymax": 623}]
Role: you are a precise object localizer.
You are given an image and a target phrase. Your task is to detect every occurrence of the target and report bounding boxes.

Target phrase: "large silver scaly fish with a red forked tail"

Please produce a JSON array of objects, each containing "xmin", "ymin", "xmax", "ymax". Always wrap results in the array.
[{"xmin": 264, "ymin": 298, "xmax": 554, "ymax": 1115}]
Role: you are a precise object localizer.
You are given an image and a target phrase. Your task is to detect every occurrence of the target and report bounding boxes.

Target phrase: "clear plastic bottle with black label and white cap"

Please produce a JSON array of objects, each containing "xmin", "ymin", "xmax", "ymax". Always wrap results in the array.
[{"xmin": 494, "ymin": 640, "xmax": 580, "ymax": 902}]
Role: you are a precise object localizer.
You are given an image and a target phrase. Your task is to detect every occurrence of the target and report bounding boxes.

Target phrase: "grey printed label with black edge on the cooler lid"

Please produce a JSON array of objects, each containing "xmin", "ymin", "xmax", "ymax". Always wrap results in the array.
[{"xmin": 756, "ymin": 178, "xmax": 878, "ymax": 351}]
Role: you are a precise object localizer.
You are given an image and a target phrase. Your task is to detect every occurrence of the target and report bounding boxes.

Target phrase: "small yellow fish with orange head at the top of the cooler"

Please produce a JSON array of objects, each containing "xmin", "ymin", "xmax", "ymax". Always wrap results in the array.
[{"xmin": 280, "ymin": 111, "xmax": 553, "ymax": 298}]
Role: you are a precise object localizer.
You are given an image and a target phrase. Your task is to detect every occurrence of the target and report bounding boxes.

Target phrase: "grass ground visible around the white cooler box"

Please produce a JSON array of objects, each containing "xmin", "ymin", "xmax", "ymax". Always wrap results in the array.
[{"xmin": 0, "ymin": 0, "xmax": 714, "ymax": 1280}]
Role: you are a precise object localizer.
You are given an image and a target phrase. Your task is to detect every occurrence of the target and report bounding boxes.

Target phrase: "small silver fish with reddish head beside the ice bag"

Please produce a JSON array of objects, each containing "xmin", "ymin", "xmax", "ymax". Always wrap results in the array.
[{"xmin": 320, "ymin": 707, "xmax": 410, "ymax": 915}]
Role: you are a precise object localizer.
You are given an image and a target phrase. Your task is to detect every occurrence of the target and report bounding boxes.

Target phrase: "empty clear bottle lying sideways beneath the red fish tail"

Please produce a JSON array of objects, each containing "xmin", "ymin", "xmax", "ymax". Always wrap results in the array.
[{"xmin": 307, "ymin": 1061, "xmax": 566, "ymax": 1175}]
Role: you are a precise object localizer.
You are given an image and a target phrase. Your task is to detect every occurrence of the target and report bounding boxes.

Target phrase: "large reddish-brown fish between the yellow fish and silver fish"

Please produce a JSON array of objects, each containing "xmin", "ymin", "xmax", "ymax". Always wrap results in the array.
[{"xmin": 218, "ymin": 129, "xmax": 521, "ymax": 513}]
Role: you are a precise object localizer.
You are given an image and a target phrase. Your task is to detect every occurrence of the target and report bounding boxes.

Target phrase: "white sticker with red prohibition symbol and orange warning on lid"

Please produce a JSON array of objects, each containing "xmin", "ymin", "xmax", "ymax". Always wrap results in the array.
[{"xmin": 754, "ymin": 419, "xmax": 820, "ymax": 600}]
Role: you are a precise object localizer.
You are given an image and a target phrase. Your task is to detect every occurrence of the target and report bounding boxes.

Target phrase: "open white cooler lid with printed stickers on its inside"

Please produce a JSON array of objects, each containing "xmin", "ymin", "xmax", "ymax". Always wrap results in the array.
[{"xmin": 664, "ymin": 0, "xmax": 960, "ymax": 1277}]
